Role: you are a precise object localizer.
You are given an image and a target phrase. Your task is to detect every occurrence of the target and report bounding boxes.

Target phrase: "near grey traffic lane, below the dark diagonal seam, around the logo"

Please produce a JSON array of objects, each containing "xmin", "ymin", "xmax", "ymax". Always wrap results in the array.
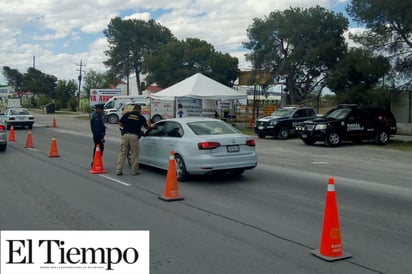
[{"xmin": 0, "ymin": 140, "xmax": 368, "ymax": 273}]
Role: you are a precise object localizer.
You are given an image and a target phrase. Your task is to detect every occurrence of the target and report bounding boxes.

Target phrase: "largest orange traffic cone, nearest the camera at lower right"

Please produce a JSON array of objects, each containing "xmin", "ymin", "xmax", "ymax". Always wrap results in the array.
[{"xmin": 311, "ymin": 178, "xmax": 352, "ymax": 262}]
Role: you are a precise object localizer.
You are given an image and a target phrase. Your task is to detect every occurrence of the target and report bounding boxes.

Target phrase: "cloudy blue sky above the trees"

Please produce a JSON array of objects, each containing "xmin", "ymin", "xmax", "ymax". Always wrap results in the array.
[{"xmin": 0, "ymin": 0, "xmax": 354, "ymax": 84}]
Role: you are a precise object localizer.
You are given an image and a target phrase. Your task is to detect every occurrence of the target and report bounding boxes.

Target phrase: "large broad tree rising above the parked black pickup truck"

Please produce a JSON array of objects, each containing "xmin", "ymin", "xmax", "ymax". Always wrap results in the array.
[{"xmin": 244, "ymin": 6, "xmax": 349, "ymax": 104}]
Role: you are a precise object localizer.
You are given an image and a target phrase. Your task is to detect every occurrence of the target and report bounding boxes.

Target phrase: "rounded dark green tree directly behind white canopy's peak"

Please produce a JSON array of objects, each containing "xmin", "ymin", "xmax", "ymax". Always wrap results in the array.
[{"xmin": 144, "ymin": 38, "xmax": 239, "ymax": 87}]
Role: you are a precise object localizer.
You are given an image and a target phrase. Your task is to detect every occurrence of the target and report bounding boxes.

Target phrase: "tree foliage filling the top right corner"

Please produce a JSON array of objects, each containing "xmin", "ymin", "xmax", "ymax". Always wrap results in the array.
[{"xmin": 347, "ymin": 0, "xmax": 412, "ymax": 88}]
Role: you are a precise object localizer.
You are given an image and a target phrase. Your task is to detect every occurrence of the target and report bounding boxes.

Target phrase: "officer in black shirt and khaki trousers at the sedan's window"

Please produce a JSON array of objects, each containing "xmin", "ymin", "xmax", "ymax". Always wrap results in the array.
[{"xmin": 116, "ymin": 104, "xmax": 149, "ymax": 176}]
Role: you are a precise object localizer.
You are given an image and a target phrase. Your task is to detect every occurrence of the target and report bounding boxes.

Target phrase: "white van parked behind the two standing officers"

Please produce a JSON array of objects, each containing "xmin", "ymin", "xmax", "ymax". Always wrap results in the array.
[{"xmin": 104, "ymin": 96, "xmax": 149, "ymax": 124}]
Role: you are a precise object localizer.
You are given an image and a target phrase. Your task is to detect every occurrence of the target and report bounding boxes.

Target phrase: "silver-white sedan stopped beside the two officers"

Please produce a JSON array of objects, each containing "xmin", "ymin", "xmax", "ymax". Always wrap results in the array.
[{"xmin": 139, "ymin": 117, "xmax": 257, "ymax": 181}]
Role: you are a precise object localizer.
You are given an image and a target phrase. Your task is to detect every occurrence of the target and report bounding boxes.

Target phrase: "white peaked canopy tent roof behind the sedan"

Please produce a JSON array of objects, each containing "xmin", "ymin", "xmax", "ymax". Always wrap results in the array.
[{"xmin": 151, "ymin": 73, "xmax": 247, "ymax": 100}]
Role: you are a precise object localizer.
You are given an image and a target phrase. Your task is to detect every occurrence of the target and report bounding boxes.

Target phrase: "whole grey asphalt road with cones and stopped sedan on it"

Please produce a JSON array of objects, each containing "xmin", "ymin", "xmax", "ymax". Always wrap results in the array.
[{"xmin": 0, "ymin": 115, "xmax": 412, "ymax": 274}]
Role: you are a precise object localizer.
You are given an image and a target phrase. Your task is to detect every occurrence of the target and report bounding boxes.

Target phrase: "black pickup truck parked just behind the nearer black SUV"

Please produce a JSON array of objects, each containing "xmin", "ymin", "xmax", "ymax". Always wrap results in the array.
[{"xmin": 254, "ymin": 107, "xmax": 316, "ymax": 140}]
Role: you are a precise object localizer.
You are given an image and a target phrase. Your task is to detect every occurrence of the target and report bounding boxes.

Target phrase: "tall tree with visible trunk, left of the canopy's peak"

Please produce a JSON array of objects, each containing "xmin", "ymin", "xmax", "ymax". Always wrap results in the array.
[{"xmin": 103, "ymin": 17, "xmax": 175, "ymax": 95}]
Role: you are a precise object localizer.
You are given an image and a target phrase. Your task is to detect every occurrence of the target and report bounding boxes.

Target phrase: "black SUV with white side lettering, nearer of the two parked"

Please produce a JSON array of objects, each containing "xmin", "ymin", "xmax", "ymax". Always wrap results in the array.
[{"xmin": 296, "ymin": 105, "xmax": 397, "ymax": 147}]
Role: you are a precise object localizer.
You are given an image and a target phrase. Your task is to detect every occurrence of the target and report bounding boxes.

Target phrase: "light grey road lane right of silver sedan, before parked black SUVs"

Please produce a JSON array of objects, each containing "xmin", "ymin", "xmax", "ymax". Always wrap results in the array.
[{"xmin": 256, "ymin": 138, "xmax": 412, "ymax": 187}]
